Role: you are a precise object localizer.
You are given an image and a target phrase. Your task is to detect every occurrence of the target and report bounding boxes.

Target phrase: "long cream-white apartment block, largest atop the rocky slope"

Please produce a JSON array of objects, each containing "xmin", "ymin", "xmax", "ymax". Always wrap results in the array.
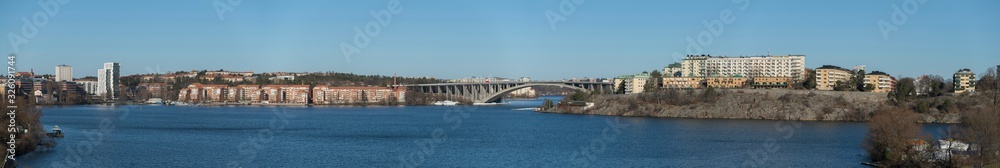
[{"xmin": 681, "ymin": 55, "xmax": 806, "ymax": 80}]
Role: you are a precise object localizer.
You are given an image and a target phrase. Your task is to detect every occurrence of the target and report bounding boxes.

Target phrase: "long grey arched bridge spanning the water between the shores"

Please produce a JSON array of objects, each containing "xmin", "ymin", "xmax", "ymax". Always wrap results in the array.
[{"xmin": 406, "ymin": 81, "xmax": 613, "ymax": 103}]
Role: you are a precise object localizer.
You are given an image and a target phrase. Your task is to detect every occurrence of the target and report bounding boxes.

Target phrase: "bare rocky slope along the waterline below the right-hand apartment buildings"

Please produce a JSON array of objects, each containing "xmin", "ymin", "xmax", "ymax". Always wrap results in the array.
[{"xmin": 541, "ymin": 89, "xmax": 961, "ymax": 123}]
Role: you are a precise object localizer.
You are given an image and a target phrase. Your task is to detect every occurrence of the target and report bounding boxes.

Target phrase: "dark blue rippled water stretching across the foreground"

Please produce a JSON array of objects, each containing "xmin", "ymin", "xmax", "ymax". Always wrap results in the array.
[{"xmin": 18, "ymin": 96, "xmax": 948, "ymax": 167}]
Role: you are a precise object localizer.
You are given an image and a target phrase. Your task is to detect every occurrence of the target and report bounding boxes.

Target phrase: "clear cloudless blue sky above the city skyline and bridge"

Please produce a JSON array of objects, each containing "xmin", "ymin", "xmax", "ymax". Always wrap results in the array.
[{"xmin": 0, "ymin": 0, "xmax": 1000, "ymax": 79}]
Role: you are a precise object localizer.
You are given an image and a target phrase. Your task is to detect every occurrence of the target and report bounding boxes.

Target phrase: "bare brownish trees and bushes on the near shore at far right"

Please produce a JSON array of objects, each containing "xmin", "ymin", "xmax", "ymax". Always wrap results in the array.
[{"xmin": 863, "ymin": 68, "xmax": 1000, "ymax": 167}]
